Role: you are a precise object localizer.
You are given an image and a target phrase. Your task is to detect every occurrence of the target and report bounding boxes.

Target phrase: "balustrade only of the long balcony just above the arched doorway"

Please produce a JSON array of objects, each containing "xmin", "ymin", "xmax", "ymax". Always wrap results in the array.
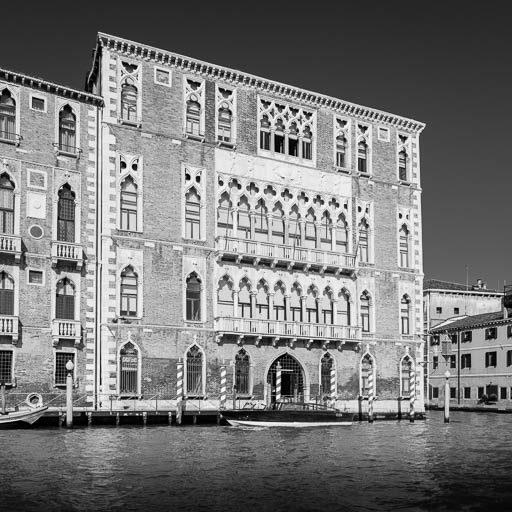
[{"xmin": 215, "ymin": 317, "xmax": 361, "ymax": 341}]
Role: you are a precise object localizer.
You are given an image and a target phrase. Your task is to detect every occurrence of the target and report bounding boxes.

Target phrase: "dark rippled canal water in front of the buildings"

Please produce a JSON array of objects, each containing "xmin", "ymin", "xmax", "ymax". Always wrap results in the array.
[{"xmin": 0, "ymin": 411, "xmax": 512, "ymax": 512}]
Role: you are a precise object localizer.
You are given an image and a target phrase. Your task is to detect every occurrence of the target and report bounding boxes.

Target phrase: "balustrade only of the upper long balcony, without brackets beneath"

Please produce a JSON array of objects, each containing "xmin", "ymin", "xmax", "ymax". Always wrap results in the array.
[{"xmin": 215, "ymin": 236, "xmax": 355, "ymax": 268}]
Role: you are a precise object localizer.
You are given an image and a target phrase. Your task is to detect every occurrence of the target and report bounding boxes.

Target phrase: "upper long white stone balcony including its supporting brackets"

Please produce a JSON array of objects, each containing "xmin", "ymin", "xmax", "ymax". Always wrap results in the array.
[{"xmin": 216, "ymin": 236, "xmax": 355, "ymax": 274}]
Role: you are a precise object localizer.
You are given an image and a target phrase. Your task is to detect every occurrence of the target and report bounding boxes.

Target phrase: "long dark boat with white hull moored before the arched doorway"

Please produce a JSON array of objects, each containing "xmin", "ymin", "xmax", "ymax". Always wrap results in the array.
[{"xmin": 221, "ymin": 402, "xmax": 352, "ymax": 427}]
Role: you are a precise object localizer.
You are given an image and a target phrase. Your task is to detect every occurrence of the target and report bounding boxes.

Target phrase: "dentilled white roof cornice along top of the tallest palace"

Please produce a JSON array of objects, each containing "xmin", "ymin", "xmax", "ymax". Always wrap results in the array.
[{"xmin": 92, "ymin": 32, "xmax": 425, "ymax": 134}]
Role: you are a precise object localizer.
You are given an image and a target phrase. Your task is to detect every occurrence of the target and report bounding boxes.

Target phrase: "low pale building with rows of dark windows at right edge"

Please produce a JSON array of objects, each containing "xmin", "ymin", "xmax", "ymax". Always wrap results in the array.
[{"xmin": 429, "ymin": 286, "xmax": 512, "ymax": 407}]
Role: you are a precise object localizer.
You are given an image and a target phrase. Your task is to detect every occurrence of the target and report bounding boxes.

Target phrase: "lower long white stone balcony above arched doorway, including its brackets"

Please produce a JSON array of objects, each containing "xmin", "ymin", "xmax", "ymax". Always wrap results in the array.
[{"xmin": 215, "ymin": 317, "xmax": 361, "ymax": 349}]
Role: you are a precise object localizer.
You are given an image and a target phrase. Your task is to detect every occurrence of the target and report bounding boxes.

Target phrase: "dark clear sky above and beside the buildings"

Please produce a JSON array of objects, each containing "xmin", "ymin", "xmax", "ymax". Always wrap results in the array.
[{"xmin": 0, "ymin": 0, "xmax": 512, "ymax": 288}]
